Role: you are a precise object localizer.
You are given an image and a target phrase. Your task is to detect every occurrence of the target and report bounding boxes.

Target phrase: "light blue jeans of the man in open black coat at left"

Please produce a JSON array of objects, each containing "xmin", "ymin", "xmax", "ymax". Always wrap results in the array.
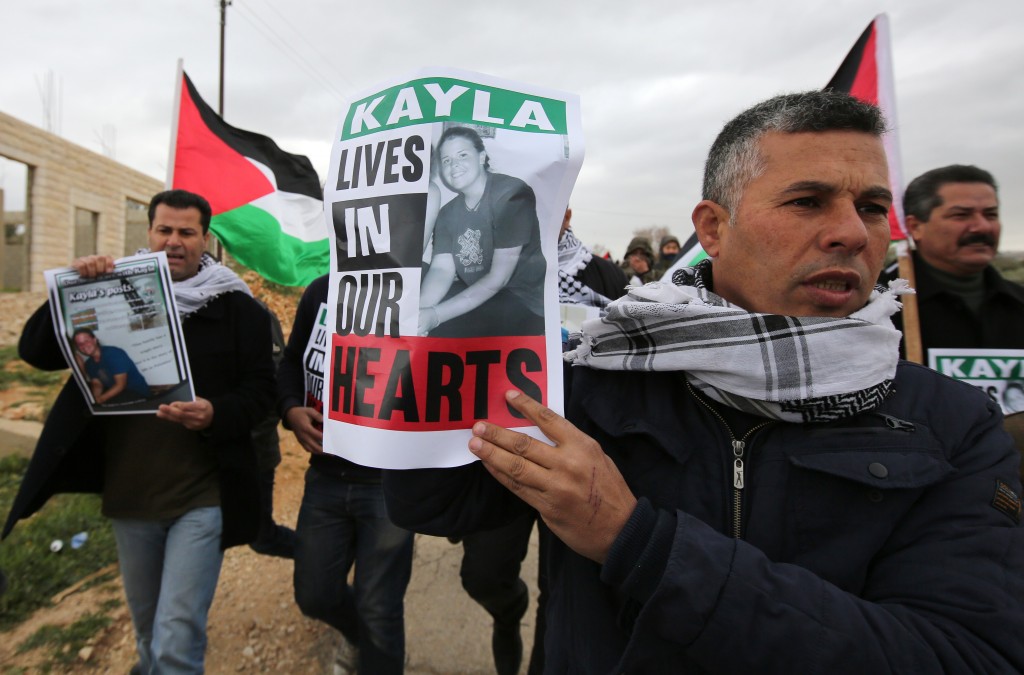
[{"xmin": 112, "ymin": 506, "xmax": 224, "ymax": 675}]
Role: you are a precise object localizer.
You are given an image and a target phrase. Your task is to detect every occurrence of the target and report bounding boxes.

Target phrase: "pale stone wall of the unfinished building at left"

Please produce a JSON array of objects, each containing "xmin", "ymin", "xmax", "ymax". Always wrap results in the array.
[{"xmin": 0, "ymin": 113, "xmax": 164, "ymax": 291}]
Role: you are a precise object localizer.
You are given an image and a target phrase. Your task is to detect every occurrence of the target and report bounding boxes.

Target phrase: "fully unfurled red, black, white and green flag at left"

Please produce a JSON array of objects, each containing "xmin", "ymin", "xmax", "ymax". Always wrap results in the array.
[{"xmin": 168, "ymin": 71, "xmax": 331, "ymax": 286}]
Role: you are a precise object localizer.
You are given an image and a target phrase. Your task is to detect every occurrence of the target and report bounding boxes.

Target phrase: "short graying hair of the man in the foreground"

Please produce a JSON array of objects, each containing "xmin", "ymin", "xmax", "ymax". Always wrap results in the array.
[{"xmin": 703, "ymin": 89, "xmax": 886, "ymax": 214}]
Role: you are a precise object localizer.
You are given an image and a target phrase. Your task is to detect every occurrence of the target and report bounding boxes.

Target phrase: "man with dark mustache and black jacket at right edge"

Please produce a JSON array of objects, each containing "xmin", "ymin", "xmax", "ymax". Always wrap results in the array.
[{"xmin": 884, "ymin": 164, "xmax": 1024, "ymax": 364}]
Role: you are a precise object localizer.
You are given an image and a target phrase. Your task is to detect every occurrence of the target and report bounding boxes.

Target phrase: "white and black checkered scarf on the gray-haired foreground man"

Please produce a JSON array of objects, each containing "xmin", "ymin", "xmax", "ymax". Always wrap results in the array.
[{"xmin": 564, "ymin": 260, "xmax": 912, "ymax": 422}]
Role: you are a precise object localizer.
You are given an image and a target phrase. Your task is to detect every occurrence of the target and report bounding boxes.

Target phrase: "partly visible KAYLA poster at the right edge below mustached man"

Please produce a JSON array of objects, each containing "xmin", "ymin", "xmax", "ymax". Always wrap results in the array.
[{"xmin": 928, "ymin": 347, "xmax": 1024, "ymax": 415}]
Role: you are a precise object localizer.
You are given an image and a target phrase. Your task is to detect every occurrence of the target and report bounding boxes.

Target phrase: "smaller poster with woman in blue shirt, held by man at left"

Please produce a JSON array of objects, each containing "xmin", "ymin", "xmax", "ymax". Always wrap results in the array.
[{"xmin": 44, "ymin": 251, "xmax": 196, "ymax": 415}]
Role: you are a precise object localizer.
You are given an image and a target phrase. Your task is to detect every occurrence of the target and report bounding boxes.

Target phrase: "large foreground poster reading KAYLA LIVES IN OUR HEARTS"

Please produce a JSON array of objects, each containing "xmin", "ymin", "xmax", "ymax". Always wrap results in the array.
[{"xmin": 323, "ymin": 69, "xmax": 584, "ymax": 468}]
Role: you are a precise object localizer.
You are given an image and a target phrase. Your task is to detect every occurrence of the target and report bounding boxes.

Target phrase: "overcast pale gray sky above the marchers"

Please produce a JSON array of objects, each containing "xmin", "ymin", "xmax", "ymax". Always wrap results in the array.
[{"xmin": 0, "ymin": 0, "xmax": 1024, "ymax": 257}]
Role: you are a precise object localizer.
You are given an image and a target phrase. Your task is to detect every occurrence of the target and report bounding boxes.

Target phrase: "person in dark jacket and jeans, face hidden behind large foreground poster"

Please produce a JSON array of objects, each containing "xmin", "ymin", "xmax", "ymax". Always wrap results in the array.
[{"xmin": 278, "ymin": 275, "xmax": 413, "ymax": 675}]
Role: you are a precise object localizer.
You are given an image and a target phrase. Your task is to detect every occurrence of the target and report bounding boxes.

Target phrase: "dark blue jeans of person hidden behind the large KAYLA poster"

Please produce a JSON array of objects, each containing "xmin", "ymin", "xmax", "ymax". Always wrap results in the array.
[{"xmin": 295, "ymin": 467, "xmax": 413, "ymax": 675}]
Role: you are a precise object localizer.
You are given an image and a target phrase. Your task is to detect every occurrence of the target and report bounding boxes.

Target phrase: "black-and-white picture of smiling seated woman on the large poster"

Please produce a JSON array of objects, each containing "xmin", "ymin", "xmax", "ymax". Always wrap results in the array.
[{"xmin": 419, "ymin": 127, "xmax": 545, "ymax": 337}]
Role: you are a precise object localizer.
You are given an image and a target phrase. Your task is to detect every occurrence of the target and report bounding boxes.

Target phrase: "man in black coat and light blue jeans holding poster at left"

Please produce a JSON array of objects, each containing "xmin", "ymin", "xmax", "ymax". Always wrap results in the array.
[{"xmin": 3, "ymin": 189, "xmax": 274, "ymax": 674}]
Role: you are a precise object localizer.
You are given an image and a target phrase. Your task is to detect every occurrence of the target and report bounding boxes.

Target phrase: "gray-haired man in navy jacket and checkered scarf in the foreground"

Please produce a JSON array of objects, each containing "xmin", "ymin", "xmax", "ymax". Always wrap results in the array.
[{"xmin": 385, "ymin": 91, "xmax": 1024, "ymax": 673}]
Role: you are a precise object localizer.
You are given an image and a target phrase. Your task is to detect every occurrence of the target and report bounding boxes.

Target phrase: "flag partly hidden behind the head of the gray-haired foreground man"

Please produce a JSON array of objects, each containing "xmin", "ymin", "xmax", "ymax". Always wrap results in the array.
[{"xmin": 825, "ymin": 14, "xmax": 907, "ymax": 241}]
